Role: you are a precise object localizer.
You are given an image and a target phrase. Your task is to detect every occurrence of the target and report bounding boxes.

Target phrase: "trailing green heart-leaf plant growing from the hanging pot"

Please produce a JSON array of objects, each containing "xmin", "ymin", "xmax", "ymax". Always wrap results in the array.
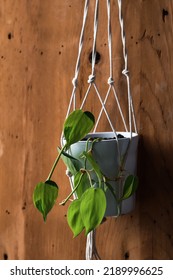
[{"xmin": 33, "ymin": 109, "xmax": 137, "ymax": 237}]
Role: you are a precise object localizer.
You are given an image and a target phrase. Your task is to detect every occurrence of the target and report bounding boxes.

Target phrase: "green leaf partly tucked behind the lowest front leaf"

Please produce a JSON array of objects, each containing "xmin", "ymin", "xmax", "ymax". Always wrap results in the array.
[{"xmin": 67, "ymin": 199, "xmax": 84, "ymax": 237}]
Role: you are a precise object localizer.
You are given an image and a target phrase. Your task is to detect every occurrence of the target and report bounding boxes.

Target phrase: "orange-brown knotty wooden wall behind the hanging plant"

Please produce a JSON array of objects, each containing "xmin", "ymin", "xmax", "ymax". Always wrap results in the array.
[{"xmin": 0, "ymin": 0, "xmax": 173, "ymax": 259}]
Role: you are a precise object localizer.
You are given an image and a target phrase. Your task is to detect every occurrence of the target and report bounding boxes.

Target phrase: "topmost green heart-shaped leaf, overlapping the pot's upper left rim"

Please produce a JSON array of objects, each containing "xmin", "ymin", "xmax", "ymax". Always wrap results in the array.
[{"xmin": 63, "ymin": 109, "xmax": 95, "ymax": 148}]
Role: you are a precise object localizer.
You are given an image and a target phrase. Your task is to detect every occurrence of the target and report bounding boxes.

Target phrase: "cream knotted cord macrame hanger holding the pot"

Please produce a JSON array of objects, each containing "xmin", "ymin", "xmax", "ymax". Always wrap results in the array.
[{"xmin": 63, "ymin": 0, "xmax": 137, "ymax": 260}]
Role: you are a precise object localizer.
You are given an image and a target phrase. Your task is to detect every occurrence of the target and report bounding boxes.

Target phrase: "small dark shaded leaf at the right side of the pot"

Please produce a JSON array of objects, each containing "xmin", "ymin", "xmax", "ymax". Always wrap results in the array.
[{"xmin": 120, "ymin": 175, "xmax": 138, "ymax": 200}]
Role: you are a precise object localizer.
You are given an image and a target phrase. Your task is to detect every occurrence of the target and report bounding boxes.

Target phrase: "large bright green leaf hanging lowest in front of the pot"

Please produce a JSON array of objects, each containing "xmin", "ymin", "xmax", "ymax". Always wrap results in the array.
[{"xmin": 80, "ymin": 188, "xmax": 106, "ymax": 234}]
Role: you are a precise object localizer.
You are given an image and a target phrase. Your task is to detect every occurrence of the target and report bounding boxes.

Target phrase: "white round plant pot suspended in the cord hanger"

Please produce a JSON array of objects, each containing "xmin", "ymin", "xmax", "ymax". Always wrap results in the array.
[{"xmin": 67, "ymin": 132, "xmax": 139, "ymax": 216}]
